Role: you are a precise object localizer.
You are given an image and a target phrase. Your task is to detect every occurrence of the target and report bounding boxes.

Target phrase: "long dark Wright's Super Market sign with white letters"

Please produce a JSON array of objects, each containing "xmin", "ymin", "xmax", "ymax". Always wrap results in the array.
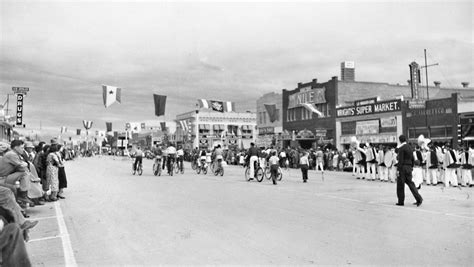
[{"xmin": 336, "ymin": 99, "xmax": 401, "ymax": 118}]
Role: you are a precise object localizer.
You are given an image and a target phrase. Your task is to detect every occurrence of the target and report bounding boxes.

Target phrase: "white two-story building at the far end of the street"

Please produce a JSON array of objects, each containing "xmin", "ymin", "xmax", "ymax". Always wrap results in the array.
[{"xmin": 176, "ymin": 109, "xmax": 257, "ymax": 149}]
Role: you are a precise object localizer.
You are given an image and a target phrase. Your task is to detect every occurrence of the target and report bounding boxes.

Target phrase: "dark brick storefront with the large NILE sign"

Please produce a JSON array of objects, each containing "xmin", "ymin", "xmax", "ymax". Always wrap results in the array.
[{"xmin": 282, "ymin": 77, "xmax": 338, "ymax": 149}]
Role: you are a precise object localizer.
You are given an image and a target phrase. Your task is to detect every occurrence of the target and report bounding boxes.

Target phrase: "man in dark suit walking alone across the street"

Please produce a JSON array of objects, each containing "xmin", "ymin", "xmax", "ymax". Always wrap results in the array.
[{"xmin": 396, "ymin": 135, "xmax": 423, "ymax": 207}]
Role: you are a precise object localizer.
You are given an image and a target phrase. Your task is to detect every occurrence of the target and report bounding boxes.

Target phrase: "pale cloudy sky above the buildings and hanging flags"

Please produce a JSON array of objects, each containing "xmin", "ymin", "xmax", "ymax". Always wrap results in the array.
[{"xmin": 0, "ymin": 0, "xmax": 474, "ymax": 137}]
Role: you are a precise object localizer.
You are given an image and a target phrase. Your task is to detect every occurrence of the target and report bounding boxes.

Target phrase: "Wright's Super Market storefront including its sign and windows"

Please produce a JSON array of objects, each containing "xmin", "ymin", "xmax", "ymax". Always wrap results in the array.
[{"xmin": 336, "ymin": 99, "xmax": 405, "ymax": 152}]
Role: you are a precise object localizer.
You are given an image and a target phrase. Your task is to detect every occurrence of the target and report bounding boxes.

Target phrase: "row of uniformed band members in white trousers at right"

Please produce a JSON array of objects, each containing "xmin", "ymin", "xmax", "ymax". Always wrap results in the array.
[{"xmin": 352, "ymin": 135, "xmax": 474, "ymax": 188}]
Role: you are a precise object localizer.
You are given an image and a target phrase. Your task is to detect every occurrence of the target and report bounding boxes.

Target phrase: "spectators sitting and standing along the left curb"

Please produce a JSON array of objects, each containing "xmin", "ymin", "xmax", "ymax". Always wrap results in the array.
[{"xmin": 0, "ymin": 139, "xmax": 75, "ymax": 266}]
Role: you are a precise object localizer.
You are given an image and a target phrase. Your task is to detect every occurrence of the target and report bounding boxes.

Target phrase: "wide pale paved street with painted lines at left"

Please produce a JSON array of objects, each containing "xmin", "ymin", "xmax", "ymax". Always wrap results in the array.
[{"xmin": 28, "ymin": 157, "xmax": 474, "ymax": 266}]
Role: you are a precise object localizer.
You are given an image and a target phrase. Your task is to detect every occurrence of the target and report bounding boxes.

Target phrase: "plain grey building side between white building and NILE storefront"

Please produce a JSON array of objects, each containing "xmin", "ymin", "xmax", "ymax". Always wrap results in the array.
[{"xmin": 256, "ymin": 92, "xmax": 283, "ymax": 148}]
